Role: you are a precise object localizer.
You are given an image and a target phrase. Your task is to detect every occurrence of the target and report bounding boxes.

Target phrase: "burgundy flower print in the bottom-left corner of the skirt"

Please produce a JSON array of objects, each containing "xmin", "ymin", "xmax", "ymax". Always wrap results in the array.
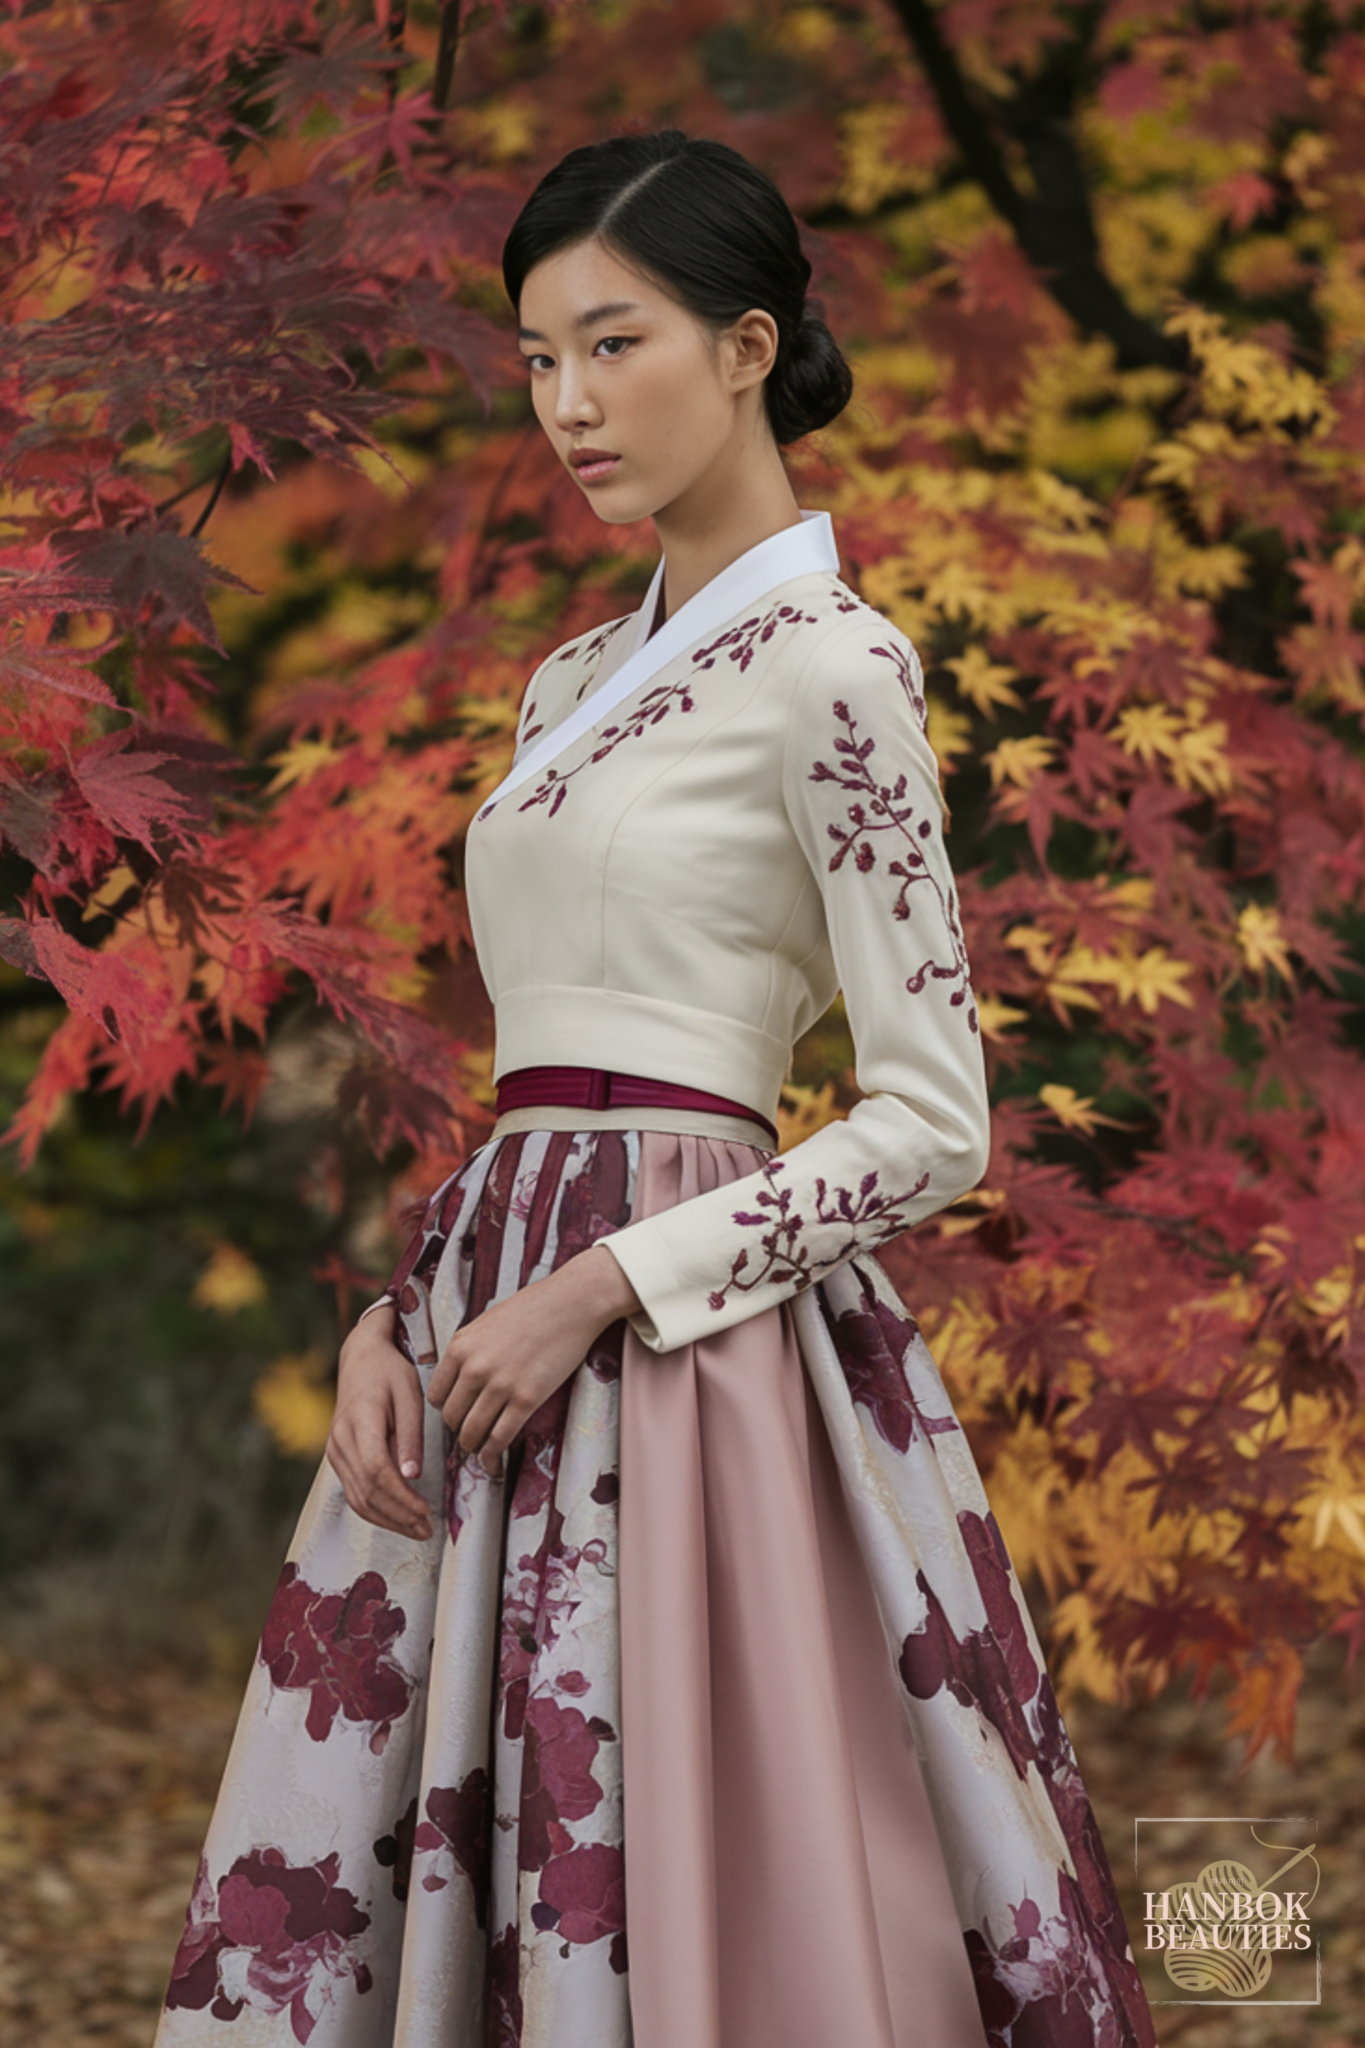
[{"xmin": 166, "ymin": 1849, "xmax": 372, "ymax": 2042}]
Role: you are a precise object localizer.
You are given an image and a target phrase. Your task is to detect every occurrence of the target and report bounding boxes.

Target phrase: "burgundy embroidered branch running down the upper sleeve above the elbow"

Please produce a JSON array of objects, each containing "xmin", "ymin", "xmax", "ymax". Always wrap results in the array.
[{"xmin": 810, "ymin": 700, "xmax": 978, "ymax": 1030}]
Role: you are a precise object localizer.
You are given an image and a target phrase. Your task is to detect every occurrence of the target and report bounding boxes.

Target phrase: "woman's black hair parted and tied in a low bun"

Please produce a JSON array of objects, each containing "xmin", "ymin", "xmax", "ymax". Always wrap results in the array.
[{"xmin": 501, "ymin": 129, "xmax": 853, "ymax": 444}]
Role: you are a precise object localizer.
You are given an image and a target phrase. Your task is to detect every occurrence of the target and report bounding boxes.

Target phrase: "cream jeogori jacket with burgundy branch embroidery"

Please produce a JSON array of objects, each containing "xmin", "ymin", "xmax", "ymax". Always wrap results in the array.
[{"xmin": 467, "ymin": 528, "xmax": 988, "ymax": 1352}]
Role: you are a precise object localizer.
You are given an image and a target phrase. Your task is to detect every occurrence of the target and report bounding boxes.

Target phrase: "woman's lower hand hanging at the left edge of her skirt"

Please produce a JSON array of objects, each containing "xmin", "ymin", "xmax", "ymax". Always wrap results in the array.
[{"xmin": 327, "ymin": 1303, "xmax": 432, "ymax": 1542}]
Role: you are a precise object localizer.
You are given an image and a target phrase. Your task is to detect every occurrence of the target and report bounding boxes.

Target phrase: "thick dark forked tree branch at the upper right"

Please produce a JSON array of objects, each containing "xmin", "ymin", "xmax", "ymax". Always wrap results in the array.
[{"xmin": 892, "ymin": 0, "xmax": 1185, "ymax": 371}]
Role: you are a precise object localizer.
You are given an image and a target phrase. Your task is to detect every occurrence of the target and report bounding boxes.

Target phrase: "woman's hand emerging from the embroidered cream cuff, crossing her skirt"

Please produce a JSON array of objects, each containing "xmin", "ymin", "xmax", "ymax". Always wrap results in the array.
[{"xmin": 426, "ymin": 1245, "xmax": 641, "ymax": 1475}]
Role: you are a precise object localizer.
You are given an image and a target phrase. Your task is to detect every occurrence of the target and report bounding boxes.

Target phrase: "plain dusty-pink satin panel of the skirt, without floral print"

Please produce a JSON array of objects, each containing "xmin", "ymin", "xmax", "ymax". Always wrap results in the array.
[{"xmin": 620, "ymin": 1133, "xmax": 984, "ymax": 2048}]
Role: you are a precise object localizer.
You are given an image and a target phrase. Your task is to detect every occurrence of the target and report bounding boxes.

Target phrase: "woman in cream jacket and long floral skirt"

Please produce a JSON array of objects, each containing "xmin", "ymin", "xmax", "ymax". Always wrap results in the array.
[{"xmin": 160, "ymin": 133, "xmax": 1152, "ymax": 2048}]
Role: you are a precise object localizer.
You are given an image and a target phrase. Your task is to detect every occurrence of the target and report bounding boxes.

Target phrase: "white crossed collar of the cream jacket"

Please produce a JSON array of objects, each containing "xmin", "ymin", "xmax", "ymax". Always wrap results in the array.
[{"xmin": 479, "ymin": 512, "xmax": 839, "ymax": 817}]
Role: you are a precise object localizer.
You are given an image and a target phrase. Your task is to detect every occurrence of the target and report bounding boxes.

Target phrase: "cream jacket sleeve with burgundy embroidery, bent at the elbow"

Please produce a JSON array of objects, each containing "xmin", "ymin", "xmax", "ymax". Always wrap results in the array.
[{"xmin": 608, "ymin": 606, "xmax": 990, "ymax": 1352}]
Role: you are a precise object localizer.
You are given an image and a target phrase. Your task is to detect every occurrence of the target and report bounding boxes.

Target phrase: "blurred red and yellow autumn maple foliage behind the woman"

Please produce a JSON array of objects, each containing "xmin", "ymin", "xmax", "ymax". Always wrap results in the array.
[{"xmin": 0, "ymin": 0, "xmax": 1365, "ymax": 2048}]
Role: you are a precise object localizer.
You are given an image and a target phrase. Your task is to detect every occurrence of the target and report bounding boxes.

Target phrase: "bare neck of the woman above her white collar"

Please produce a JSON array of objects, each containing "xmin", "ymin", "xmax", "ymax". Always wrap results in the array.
[{"xmin": 655, "ymin": 407, "xmax": 800, "ymax": 618}]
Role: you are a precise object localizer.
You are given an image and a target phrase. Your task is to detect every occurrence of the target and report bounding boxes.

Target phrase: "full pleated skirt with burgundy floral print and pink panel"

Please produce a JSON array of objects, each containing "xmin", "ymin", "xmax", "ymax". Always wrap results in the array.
[{"xmin": 158, "ymin": 1130, "xmax": 1154, "ymax": 2048}]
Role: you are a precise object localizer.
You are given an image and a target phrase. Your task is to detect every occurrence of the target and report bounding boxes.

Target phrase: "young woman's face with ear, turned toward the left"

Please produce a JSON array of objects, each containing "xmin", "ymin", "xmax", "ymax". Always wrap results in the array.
[{"xmin": 520, "ymin": 242, "xmax": 776, "ymax": 524}]
